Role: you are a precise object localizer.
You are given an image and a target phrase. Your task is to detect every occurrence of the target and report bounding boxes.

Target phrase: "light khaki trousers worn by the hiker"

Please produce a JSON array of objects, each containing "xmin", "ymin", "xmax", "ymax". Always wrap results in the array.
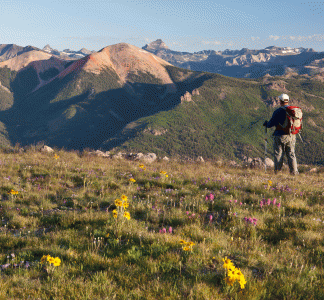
[{"xmin": 273, "ymin": 134, "xmax": 298, "ymax": 175}]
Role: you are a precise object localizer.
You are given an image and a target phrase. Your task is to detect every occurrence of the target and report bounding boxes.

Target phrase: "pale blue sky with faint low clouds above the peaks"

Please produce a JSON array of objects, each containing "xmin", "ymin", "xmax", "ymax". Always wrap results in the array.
[{"xmin": 0, "ymin": 0, "xmax": 324, "ymax": 52}]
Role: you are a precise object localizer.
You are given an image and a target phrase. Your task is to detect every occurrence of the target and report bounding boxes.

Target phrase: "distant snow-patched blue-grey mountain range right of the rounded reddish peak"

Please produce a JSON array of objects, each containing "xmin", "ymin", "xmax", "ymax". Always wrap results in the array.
[{"xmin": 143, "ymin": 39, "xmax": 324, "ymax": 78}]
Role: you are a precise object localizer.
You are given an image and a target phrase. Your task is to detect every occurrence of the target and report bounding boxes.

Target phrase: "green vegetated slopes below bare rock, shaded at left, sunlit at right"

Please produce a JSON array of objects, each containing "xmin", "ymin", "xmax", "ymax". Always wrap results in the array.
[{"xmin": 0, "ymin": 63, "xmax": 324, "ymax": 163}]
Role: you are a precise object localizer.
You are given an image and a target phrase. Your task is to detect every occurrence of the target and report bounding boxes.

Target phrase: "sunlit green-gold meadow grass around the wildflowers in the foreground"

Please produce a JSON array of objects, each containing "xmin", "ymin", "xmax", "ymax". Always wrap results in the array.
[{"xmin": 0, "ymin": 147, "xmax": 324, "ymax": 300}]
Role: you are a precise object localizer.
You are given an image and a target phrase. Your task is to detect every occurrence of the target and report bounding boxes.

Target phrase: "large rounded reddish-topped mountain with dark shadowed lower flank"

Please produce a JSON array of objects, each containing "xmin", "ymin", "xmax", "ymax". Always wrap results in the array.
[{"xmin": 0, "ymin": 44, "xmax": 208, "ymax": 149}]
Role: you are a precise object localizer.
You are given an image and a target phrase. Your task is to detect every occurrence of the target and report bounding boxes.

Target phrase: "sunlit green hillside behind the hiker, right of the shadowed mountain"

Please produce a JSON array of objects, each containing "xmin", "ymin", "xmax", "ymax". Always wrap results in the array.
[{"xmin": 111, "ymin": 69, "xmax": 324, "ymax": 164}]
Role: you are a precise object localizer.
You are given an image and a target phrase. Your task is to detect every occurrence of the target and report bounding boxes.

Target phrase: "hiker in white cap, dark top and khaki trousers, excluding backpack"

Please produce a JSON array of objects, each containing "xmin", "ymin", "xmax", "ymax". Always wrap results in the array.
[{"xmin": 263, "ymin": 94, "xmax": 298, "ymax": 175}]
